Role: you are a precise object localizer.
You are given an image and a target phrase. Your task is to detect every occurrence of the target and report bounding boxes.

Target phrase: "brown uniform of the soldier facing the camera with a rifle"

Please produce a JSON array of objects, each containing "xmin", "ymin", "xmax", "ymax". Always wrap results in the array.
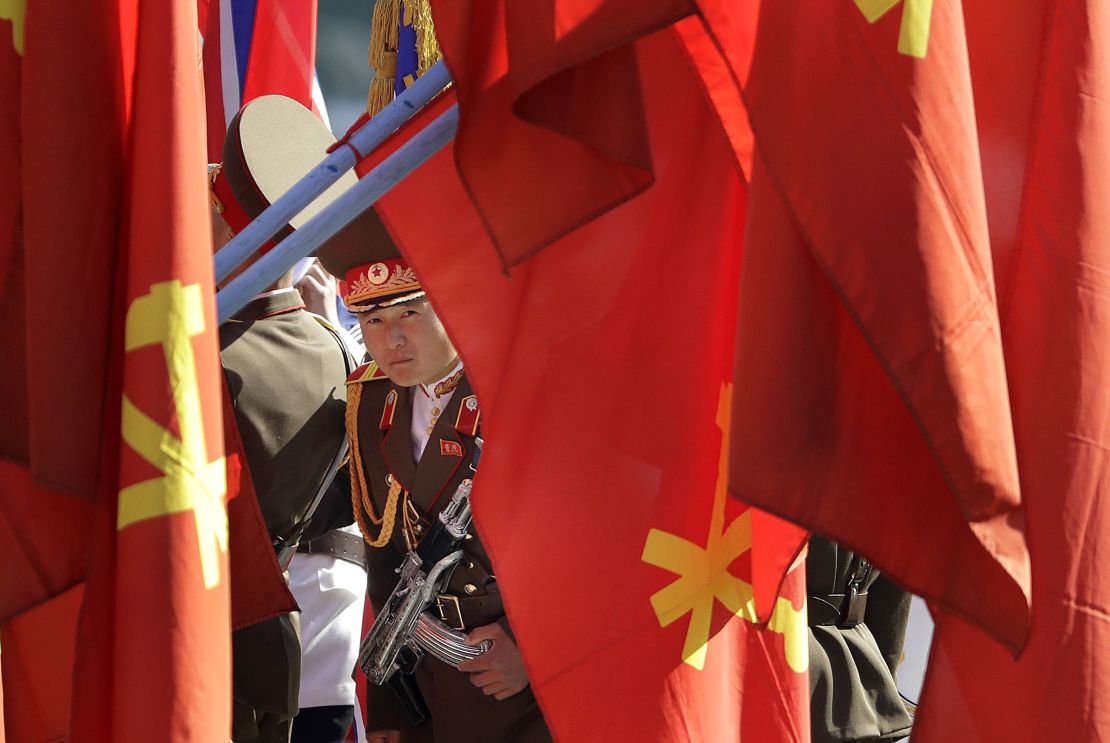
[{"xmin": 349, "ymin": 363, "xmax": 551, "ymax": 743}]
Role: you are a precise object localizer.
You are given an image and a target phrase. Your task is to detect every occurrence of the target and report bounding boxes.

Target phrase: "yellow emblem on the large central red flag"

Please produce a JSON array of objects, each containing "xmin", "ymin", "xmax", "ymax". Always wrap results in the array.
[{"xmin": 640, "ymin": 384, "xmax": 809, "ymax": 673}]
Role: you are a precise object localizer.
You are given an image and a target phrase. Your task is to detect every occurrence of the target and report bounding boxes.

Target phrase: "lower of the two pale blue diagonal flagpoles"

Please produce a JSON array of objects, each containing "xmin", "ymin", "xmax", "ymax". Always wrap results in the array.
[{"xmin": 216, "ymin": 102, "xmax": 458, "ymax": 323}]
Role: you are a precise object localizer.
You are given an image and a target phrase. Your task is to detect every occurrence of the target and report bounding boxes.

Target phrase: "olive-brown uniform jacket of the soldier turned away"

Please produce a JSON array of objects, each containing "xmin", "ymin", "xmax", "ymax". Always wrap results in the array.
[{"xmin": 220, "ymin": 290, "xmax": 350, "ymax": 716}]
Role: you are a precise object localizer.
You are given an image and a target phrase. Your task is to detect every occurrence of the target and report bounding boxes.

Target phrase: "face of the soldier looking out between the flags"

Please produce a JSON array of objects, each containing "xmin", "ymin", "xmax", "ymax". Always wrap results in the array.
[{"xmin": 359, "ymin": 299, "xmax": 458, "ymax": 386}]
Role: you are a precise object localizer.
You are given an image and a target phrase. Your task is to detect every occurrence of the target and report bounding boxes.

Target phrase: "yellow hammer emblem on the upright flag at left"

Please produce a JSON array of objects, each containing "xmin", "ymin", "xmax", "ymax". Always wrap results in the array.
[{"xmin": 117, "ymin": 280, "xmax": 228, "ymax": 589}]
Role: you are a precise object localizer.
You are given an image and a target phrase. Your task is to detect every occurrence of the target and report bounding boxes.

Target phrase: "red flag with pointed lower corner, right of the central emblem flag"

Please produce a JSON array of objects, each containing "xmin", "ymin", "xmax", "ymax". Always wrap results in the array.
[{"xmin": 706, "ymin": 0, "xmax": 1029, "ymax": 647}]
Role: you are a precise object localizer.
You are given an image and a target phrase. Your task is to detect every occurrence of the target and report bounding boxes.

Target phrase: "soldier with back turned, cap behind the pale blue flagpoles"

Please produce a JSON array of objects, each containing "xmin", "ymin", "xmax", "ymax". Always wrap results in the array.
[{"xmin": 212, "ymin": 99, "xmax": 354, "ymax": 743}]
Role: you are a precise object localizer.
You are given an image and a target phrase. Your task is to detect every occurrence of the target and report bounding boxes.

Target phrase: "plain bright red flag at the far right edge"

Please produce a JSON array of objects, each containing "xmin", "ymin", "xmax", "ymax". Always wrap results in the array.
[{"xmin": 914, "ymin": 0, "xmax": 1110, "ymax": 743}]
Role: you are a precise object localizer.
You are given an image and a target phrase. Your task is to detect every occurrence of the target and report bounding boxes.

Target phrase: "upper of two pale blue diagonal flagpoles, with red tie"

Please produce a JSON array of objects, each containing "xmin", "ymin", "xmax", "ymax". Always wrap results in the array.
[{"xmin": 209, "ymin": 61, "xmax": 451, "ymax": 284}]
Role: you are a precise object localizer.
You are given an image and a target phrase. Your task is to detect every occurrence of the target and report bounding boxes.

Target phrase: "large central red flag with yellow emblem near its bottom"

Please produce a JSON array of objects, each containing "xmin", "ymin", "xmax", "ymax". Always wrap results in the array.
[{"xmin": 368, "ymin": 3, "xmax": 808, "ymax": 741}]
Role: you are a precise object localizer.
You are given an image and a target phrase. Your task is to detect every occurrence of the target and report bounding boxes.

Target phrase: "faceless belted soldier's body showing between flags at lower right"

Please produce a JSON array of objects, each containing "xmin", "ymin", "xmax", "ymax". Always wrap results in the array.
[{"xmin": 806, "ymin": 536, "xmax": 912, "ymax": 743}]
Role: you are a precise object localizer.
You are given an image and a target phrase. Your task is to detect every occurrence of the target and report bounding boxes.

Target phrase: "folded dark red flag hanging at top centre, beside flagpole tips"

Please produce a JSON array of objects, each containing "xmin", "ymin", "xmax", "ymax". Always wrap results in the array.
[{"xmin": 432, "ymin": 0, "xmax": 695, "ymax": 265}]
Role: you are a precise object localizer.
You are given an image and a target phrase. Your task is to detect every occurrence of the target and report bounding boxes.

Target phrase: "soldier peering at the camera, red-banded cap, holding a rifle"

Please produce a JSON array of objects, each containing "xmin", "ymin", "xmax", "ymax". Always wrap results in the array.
[{"xmin": 317, "ymin": 215, "xmax": 551, "ymax": 743}]
